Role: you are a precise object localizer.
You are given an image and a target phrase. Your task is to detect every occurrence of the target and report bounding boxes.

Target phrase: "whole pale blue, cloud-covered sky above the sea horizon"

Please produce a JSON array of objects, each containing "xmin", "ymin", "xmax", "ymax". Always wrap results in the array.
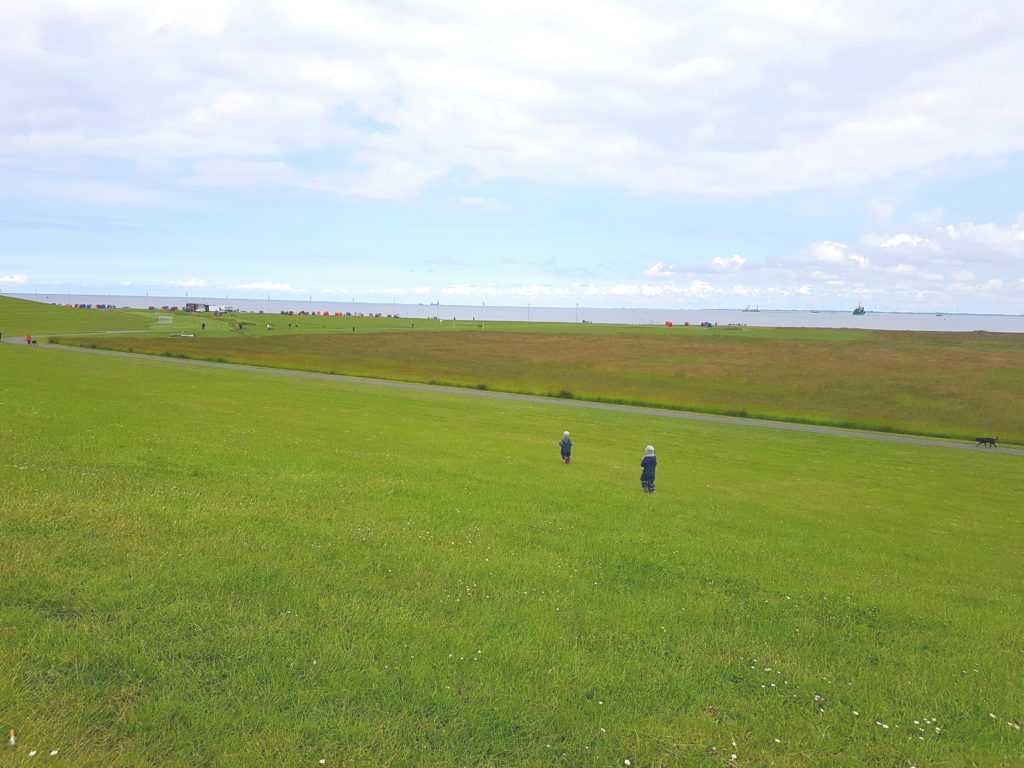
[{"xmin": 0, "ymin": 0, "xmax": 1024, "ymax": 314}]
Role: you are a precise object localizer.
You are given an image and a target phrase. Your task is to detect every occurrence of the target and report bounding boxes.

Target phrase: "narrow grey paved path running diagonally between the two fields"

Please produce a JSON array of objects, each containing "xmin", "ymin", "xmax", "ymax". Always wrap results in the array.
[{"xmin": 3, "ymin": 331, "xmax": 1024, "ymax": 456}]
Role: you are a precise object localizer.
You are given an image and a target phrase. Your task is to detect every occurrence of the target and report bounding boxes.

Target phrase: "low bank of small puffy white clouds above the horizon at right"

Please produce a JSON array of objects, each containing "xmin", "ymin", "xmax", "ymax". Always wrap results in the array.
[{"xmin": 374, "ymin": 211, "xmax": 1024, "ymax": 311}]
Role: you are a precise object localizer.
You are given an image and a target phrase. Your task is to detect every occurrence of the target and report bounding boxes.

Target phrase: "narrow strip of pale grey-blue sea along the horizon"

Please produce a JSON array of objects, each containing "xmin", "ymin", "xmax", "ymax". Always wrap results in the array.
[{"xmin": 4, "ymin": 293, "xmax": 1024, "ymax": 333}]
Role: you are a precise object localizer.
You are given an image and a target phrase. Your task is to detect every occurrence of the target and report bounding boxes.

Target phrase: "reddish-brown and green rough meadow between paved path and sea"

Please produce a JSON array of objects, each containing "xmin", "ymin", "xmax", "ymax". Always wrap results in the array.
[{"xmin": 44, "ymin": 303, "xmax": 1024, "ymax": 444}]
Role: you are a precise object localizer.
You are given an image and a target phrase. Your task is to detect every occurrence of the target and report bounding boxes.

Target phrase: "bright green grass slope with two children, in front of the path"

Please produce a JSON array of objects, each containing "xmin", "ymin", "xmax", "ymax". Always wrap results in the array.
[{"xmin": 0, "ymin": 327, "xmax": 1024, "ymax": 768}]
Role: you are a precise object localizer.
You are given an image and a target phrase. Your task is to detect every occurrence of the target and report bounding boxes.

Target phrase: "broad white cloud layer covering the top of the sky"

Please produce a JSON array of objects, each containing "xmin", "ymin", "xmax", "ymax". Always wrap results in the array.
[{"xmin": 0, "ymin": 0, "xmax": 1024, "ymax": 202}]
